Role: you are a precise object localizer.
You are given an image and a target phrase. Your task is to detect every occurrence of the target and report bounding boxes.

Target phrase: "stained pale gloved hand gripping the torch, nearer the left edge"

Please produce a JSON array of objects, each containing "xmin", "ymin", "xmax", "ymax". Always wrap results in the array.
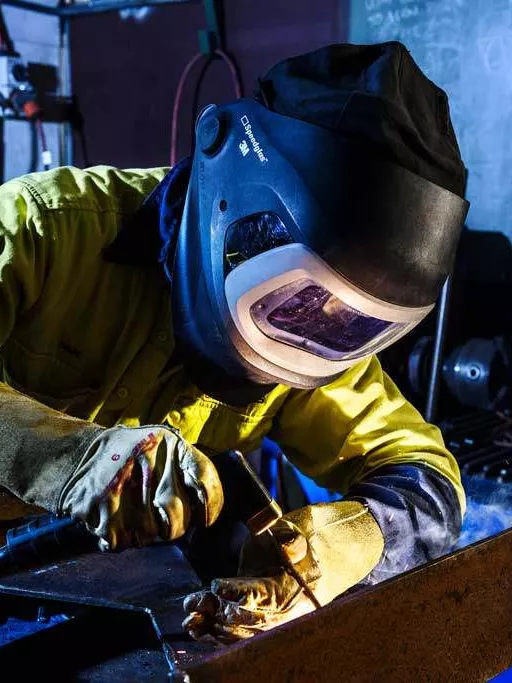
[{"xmin": 58, "ymin": 425, "xmax": 224, "ymax": 550}]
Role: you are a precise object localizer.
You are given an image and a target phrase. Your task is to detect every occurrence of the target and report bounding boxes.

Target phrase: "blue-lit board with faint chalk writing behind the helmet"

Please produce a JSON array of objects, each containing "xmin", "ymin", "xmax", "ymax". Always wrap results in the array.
[{"xmin": 349, "ymin": 0, "xmax": 512, "ymax": 238}]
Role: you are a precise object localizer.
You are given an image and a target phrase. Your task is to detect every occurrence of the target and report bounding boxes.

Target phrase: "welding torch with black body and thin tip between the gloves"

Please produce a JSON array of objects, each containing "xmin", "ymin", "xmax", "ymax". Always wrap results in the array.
[{"xmin": 0, "ymin": 450, "xmax": 320, "ymax": 608}]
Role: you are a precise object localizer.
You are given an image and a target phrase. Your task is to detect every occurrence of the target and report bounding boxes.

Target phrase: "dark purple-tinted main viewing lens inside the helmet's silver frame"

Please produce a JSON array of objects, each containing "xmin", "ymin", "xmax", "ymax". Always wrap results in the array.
[{"xmin": 251, "ymin": 283, "xmax": 394, "ymax": 356}]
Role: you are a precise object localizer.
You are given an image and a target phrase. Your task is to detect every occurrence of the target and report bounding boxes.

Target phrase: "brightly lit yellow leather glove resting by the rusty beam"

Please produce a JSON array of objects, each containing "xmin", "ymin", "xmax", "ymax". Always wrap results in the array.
[{"xmin": 183, "ymin": 501, "xmax": 384, "ymax": 642}]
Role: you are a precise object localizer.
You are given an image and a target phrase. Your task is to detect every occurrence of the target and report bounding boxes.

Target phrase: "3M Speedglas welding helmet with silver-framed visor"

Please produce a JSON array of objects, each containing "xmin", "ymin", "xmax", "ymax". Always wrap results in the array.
[{"xmin": 173, "ymin": 43, "xmax": 468, "ymax": 388}]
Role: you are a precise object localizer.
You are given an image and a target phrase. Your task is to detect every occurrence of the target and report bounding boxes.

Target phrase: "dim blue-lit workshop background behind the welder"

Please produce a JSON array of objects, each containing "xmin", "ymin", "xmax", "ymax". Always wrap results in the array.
[{"xmin": 0, "ymin": 0, "xmax": 512, "ymax": 680}]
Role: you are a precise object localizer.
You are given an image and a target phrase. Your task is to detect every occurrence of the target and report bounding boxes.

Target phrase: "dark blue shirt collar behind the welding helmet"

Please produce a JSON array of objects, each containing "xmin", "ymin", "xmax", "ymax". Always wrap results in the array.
[{"xmin": 103, "ymin": 157, "xmax": 192, "ymax": 266}]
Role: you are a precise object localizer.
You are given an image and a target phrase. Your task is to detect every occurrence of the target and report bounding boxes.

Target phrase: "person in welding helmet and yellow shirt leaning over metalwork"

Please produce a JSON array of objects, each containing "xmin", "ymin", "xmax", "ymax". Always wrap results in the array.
[{"xmin": 0, "ymin": 42, "xmax": 468, "ymax": 638}]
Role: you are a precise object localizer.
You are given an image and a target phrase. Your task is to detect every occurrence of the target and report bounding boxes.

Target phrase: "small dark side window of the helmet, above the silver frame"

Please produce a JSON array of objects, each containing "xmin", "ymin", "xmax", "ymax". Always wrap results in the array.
[{"xmin": 224, "ymin": 212, "xmax": 293, "ymax": 276}]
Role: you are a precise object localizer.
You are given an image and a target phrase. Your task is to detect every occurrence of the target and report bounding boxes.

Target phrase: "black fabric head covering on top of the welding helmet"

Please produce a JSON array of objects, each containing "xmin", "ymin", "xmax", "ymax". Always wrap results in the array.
[{"xmin": 255, "ymin": 42, "xmax": 465, "ymax": 196}]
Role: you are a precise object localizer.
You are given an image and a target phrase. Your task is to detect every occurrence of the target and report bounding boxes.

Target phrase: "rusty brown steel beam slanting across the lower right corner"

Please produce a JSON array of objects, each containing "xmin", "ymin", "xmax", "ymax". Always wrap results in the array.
[{"xmin": 182, "ymin": 530, "xmax": 512, "ymax": 683}]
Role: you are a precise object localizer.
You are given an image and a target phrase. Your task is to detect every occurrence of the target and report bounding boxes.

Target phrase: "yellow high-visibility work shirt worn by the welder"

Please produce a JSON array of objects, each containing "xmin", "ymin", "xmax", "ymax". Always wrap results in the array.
[{"xmin": 0, "ymin": 166, "xmax": 465, "ymax": 510}]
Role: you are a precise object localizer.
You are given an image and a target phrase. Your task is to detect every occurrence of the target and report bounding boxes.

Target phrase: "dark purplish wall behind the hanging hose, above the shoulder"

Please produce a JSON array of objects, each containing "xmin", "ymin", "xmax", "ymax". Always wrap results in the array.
[{"xmin": 71, "ymin": 0, "xmax": 348, "ymax": 167}]
